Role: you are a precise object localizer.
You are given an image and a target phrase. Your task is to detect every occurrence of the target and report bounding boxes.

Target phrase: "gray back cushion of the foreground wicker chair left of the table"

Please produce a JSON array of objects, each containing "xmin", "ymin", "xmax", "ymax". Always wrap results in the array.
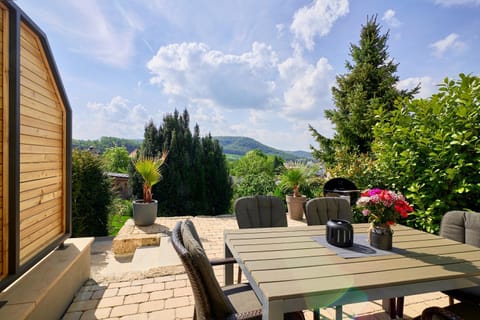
[{"xmin": 182, "ymin": 223, "xmax": 235, "ymax": 319}]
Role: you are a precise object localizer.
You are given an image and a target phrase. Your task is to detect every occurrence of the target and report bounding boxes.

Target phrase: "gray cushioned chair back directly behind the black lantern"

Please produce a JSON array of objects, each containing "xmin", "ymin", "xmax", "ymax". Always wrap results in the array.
[{"xmin": 305, "ymin": 197, "xmax": 353, "ymax": 226}]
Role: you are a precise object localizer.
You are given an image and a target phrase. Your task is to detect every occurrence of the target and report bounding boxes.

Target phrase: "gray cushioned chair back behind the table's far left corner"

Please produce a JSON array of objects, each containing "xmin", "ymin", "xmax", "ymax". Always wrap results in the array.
[{"xmin": 233, "ymin": 196, "xmax": 287, "ymax": 229}]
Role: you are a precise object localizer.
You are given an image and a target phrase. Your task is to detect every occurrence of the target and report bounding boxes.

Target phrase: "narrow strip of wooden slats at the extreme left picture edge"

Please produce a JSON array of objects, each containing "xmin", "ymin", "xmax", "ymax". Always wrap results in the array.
[{"xmin": 0, "ymin": 4, "xmax": 8, "ymax": 279}]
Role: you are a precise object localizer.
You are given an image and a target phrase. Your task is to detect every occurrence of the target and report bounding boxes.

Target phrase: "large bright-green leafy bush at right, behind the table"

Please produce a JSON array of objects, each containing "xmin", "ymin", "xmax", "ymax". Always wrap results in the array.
[{"xmin": 373, "ymin": 74, "xmax": 480, "ymax": 233}]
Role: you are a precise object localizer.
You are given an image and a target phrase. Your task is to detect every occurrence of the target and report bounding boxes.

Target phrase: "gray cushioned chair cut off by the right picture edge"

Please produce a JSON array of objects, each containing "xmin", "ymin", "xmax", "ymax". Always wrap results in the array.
[{"xmin": 440, "ymin": 211, "xmax": 480, "ymax": 304}]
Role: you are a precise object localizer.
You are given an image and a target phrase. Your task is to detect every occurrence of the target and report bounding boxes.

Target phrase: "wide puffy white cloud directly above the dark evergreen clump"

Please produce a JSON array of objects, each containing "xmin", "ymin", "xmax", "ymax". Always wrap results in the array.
[{"xmin": 147, "ymin": 43, "xmax": 278, "ymax": 109}]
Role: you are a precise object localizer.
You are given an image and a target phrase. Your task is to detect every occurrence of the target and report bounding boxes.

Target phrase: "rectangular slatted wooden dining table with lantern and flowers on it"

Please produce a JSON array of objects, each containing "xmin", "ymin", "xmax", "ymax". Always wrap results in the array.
[{"xmin": 224, "ymin": 224, "xmax": 480, "ymax": 320}]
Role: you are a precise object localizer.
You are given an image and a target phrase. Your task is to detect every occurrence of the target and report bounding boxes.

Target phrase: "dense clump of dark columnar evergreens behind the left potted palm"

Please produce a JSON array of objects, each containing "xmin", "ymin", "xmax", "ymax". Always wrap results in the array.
[{"xmin": 131, "ymin": 110, "xmax": 232, "ymax": 216}]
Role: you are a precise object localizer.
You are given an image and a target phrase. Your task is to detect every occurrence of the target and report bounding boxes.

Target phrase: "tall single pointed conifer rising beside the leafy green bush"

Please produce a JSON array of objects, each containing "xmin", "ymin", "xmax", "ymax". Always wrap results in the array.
[{"xmin": 309, "ymin": 15, "xmax": 419, "ymax": 164}]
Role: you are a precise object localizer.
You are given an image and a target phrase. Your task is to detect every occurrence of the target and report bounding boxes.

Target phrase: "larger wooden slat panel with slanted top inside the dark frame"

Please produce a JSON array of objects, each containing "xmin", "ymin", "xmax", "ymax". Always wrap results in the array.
[{"xmin": 20, "ymin": 22, "xmax": 66, "ymax": 264}]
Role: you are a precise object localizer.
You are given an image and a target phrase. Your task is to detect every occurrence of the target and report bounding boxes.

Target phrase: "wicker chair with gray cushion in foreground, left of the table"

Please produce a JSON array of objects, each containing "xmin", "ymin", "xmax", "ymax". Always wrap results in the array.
[{"xmin": 172, "ymin": 220, "xmax": 304, "ymax": 320}]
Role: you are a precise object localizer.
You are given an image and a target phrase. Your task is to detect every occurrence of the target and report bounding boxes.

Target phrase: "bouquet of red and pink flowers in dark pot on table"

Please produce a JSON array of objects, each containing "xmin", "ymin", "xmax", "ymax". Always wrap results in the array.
[{"xmin": 357, "ymin": 188, "xmax": 413, "ymax": 250}]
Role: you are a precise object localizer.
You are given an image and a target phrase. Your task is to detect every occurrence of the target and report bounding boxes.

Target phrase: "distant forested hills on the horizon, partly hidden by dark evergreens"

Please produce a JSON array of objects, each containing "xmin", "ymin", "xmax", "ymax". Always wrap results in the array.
[{"xmin": 72, "ymin": 136, "xmax": 312, "ymax": 161}]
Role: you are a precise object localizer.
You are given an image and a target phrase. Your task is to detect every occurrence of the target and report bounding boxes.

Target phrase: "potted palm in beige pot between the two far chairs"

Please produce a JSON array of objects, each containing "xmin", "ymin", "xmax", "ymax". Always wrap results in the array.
[{"xmin": 280, "ymin": 167, "xmax": 307, "ymax": 220}]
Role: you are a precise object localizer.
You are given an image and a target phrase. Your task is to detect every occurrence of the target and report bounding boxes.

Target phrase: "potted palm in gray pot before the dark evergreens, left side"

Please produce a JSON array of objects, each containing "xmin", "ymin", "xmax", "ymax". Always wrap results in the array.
[{"xmin": 133, "ymin": 151, "xmax": 168, "ymax": 226}]
